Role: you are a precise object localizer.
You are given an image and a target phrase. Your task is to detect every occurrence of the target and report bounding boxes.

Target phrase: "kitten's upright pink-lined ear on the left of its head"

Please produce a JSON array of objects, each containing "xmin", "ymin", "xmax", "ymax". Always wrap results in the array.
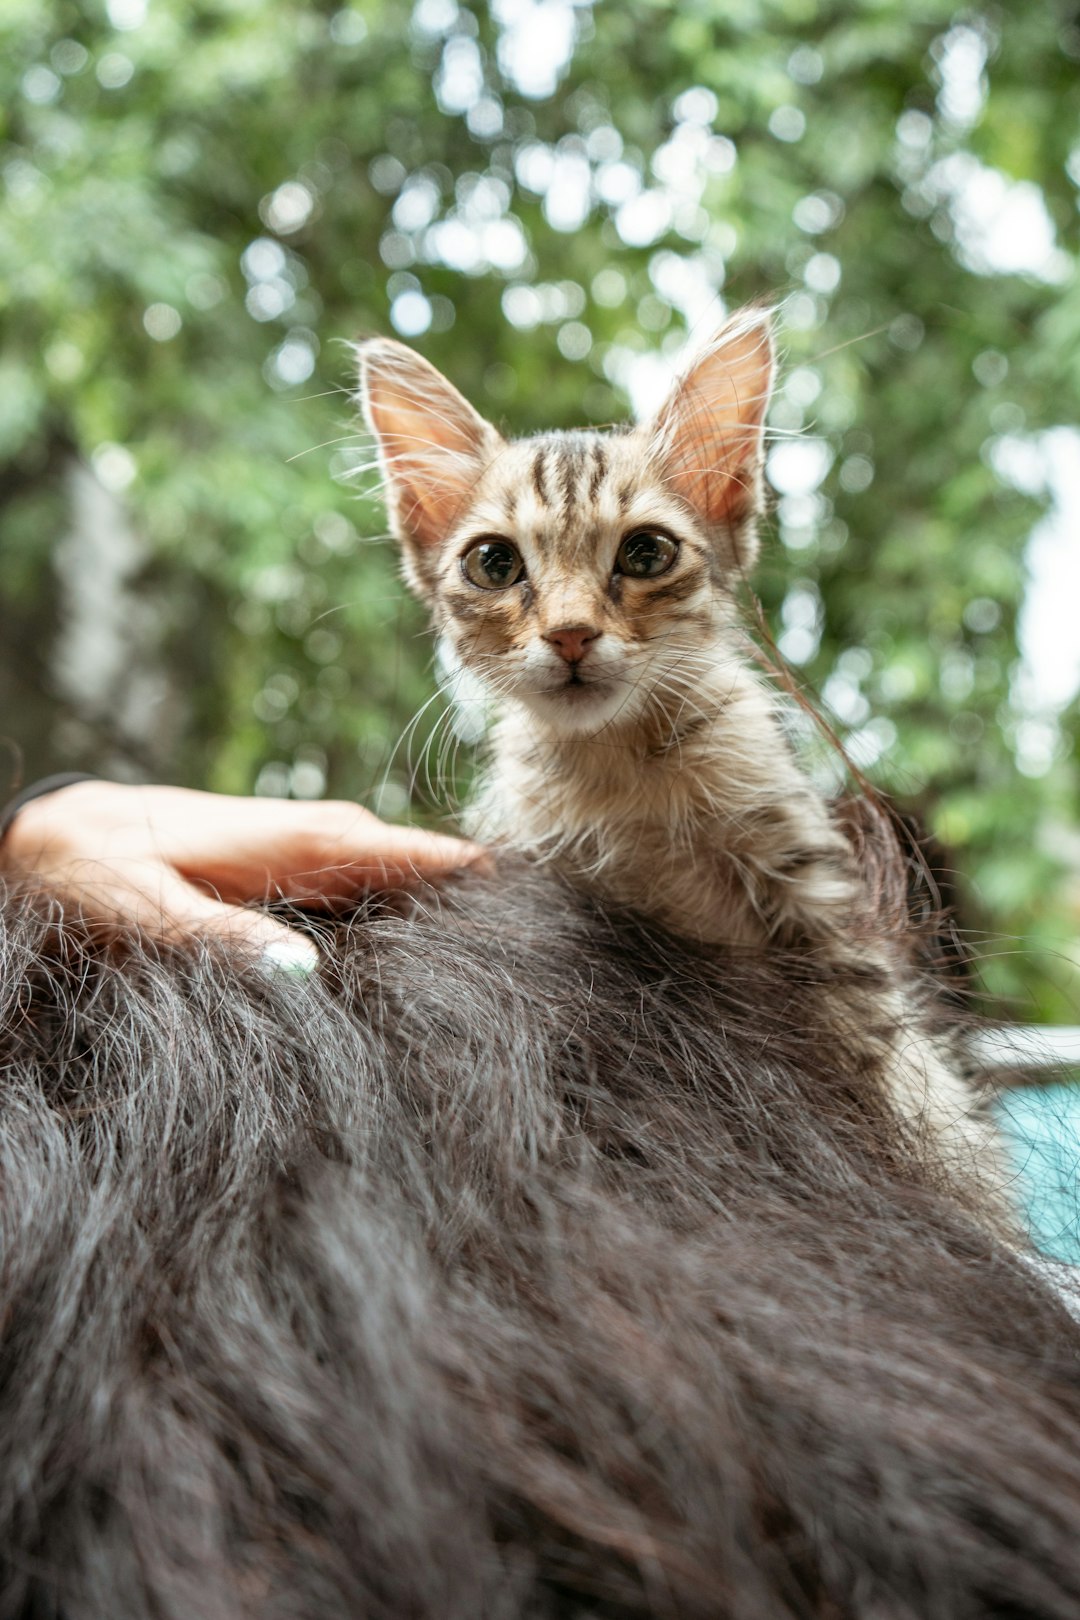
[{"xmin": 358, "ymin": 337, "xmax": 504, "ymax": 577}]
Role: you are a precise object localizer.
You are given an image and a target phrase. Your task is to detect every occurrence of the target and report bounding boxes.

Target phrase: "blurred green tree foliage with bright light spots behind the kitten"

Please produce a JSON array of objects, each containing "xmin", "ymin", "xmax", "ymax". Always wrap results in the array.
[{"xmin": 0, "ymin": 0, "xmax": 1080, "ymax": 1016}]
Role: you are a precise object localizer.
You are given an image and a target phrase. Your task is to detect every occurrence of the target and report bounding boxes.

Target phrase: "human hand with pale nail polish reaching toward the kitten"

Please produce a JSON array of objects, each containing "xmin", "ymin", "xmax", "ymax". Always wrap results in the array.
[{"xmin": 0, "ymin": 781, "xmax": 483, "ymax": 970}]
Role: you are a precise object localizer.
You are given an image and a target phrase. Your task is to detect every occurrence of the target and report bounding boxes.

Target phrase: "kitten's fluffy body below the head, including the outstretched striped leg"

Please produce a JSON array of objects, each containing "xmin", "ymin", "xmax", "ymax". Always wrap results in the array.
[{"xmin": 465, "ymin": 592, "xmax": 990, "ymax": 1202}]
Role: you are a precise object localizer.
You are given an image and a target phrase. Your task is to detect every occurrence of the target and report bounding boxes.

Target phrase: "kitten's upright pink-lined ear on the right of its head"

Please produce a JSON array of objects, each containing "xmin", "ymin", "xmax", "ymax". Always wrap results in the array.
[{"xmin": 649, "ymin": 309, "xmax": 774, "ymax": 569}]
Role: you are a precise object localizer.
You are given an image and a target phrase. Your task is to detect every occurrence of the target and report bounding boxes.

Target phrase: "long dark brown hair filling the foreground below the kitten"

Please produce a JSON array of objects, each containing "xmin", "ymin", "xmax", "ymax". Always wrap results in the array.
[{"xmin": 0, "ymin": 862, "xmax": 1080, "ymax": 1620}]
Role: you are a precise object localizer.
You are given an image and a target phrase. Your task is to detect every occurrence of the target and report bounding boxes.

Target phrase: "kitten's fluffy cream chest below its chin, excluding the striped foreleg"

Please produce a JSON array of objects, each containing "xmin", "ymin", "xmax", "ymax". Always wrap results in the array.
[{"xmin": 468, "ymin": 641, "xmax": 857, "ymax": 946}]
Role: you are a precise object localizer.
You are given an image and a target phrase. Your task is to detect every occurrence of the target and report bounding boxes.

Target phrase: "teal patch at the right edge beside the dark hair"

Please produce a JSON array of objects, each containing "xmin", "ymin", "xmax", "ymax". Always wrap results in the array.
[{"xmin": 997, "ymin": 1084, "xmax": 1080, "ymax": 1265}]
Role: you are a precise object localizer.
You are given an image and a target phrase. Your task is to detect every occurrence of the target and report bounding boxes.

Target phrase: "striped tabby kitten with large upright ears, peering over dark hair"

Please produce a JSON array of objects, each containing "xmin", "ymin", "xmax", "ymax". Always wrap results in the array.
[{"xmin": 359, "ymin": 309, "xmax": 999, "ymax": 1211}]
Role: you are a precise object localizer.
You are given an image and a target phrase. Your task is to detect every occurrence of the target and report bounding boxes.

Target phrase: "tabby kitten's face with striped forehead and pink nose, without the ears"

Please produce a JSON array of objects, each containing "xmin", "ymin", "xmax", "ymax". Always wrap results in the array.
[{"xmin": 409, "ymin": 433, "xmax": 722, "ymax": 734}]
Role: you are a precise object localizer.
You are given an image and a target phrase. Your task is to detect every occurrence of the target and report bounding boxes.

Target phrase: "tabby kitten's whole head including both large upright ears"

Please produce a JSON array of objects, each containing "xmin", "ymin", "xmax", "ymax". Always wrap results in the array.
[{"xmin": 361, "ymin": 316, "xmax": 771, "ymax": 737}]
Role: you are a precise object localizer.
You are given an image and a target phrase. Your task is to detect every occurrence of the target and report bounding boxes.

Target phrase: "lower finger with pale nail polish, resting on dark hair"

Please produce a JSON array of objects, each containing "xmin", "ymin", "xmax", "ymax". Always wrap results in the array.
[{"xmin": 50, "ymin": 860, "xmax": 319, "ymax": 974}]
